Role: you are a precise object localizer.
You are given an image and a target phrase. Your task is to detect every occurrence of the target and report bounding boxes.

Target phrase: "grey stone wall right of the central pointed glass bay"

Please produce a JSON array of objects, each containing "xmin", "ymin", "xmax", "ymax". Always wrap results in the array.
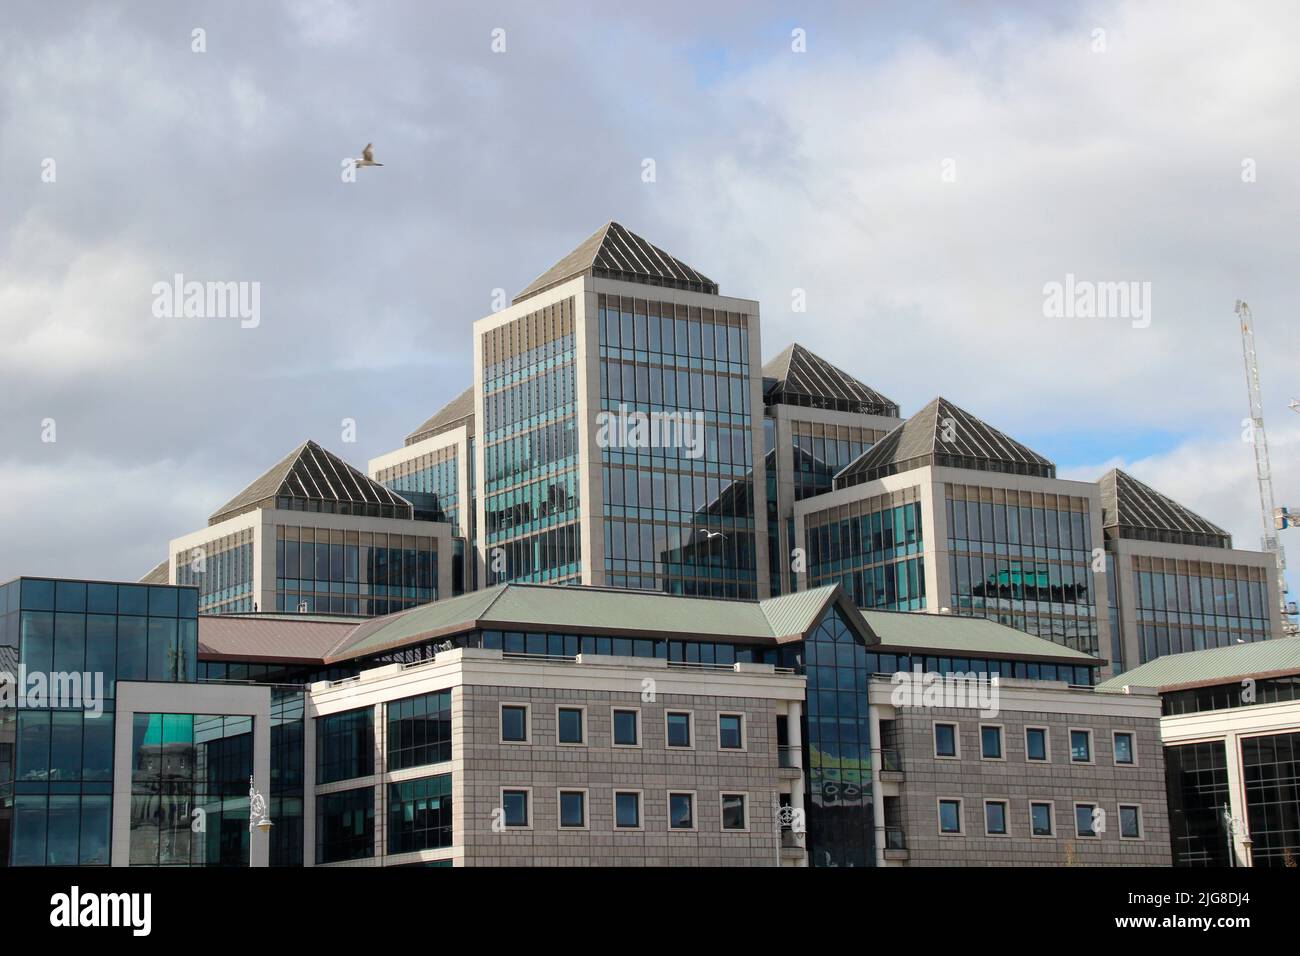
[{"xmin": 872, "ymin": 682, "xmax": 1170, "ymax": 866}]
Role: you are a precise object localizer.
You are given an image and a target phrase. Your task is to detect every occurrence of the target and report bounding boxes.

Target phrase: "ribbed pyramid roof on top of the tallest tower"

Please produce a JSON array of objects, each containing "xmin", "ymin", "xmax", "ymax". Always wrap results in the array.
[{"xmin": 514, "ymin": 221, "xmax": 718, "ymax": 302}]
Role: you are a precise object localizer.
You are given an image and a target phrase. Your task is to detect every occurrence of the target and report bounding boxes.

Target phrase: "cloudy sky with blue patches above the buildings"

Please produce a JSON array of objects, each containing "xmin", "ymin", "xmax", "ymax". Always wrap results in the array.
[{"xmin": 0, "ymin": 0, "xmax": 1300, "ymax": 598}]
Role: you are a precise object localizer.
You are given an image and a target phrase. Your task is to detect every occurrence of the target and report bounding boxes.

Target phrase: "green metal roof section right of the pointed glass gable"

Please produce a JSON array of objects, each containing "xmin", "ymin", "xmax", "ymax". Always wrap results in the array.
[{"xmin": 862, "ymin": 611, "xmax": 1101, "ymax": 665}]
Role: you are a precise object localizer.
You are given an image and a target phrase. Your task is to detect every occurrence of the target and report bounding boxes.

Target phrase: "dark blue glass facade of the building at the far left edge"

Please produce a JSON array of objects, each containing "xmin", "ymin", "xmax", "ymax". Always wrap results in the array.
[{"xmin": 0, "ymin": 578, "xmax": 197, "ymax": 866}]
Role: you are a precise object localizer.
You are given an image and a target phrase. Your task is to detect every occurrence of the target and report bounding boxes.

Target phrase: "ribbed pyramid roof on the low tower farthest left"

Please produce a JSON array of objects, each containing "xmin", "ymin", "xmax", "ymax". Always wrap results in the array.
[{"xmin": 208, "ymin": 441, "xmax": 413, "ymax": 524}]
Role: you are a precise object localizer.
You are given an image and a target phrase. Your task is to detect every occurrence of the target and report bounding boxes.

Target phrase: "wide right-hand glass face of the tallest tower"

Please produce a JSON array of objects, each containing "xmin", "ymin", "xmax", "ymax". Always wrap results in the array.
[{"xmin": 597, "ymin": 294, "xmax": 758, "ymax": 598}]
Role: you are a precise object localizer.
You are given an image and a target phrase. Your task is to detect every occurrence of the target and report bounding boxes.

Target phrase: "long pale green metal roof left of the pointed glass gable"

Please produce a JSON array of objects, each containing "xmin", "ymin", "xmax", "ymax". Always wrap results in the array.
[{"xmin": 330, "ymin": 584, "xmax": 836, "ymax": 661}]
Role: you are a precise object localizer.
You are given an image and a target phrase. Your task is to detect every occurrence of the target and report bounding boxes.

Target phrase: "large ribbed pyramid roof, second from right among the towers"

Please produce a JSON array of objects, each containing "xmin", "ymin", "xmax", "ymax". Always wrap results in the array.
[{"xmin": 835, "ymin": 397, "xmax": 1056, "ymax": 488}]
